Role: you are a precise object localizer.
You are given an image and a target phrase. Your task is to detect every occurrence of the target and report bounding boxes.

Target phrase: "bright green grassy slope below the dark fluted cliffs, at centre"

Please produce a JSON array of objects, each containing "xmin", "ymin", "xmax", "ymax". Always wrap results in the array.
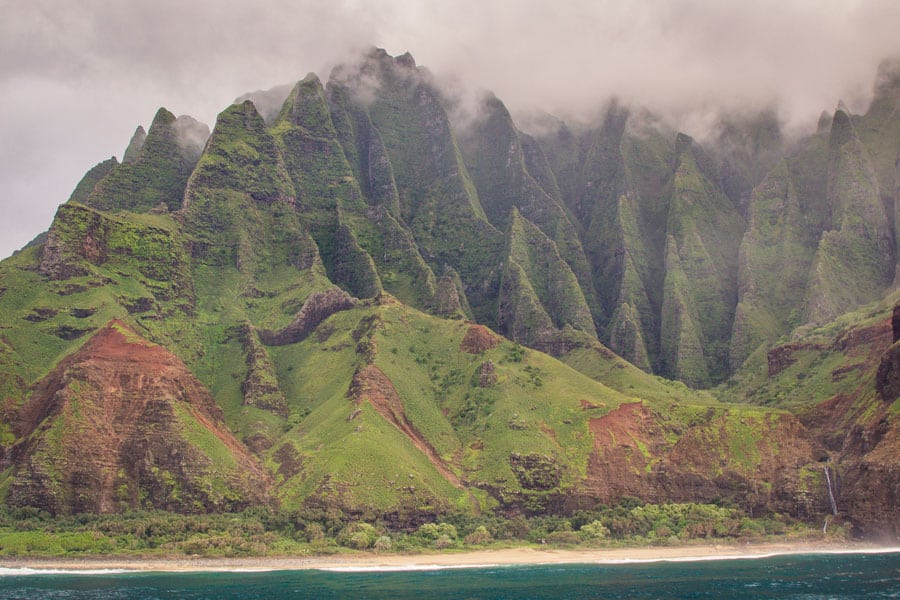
[{"xmin": 260, "ymin": 302, "xmax": 691, "ymax": 514}]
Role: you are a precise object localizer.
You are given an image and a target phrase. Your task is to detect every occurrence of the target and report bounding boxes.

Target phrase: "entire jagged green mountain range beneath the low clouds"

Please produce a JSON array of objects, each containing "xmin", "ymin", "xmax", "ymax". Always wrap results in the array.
[{"xmin": 0, "ymin": 50, "xmax": 900, "ymax": 536}]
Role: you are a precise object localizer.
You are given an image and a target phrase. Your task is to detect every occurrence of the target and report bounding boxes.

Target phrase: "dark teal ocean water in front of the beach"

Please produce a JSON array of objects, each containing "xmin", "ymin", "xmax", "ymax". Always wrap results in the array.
[{"xmin": 0, "ymin": 551, "xmax": 900, "ymax": 600}]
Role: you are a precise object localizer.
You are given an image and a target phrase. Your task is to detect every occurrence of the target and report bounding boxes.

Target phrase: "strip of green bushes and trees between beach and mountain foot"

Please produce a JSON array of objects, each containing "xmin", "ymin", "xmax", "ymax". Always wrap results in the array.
[{"xmin": 0, "ymin": 504, "xmax": 820, "ymax": 558}]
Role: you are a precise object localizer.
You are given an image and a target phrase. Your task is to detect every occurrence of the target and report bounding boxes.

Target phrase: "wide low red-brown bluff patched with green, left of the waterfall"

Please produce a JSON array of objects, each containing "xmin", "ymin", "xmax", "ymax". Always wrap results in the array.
[{"xmin": 585, "ymin": 403, "xmax": 827, "ymax": 517}]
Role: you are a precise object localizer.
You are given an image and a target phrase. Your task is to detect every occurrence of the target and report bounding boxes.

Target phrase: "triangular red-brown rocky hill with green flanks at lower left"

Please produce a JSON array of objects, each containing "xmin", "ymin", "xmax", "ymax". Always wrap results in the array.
[{"xmin": 5, "ymin": 321, "xmax": 269, "ymax": 514}]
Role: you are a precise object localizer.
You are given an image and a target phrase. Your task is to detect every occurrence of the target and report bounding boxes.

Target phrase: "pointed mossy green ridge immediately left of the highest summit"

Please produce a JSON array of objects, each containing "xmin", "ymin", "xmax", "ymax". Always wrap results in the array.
[{"xmin": 273, "ymin": 75, "xmax": 435, "ymax": 309}]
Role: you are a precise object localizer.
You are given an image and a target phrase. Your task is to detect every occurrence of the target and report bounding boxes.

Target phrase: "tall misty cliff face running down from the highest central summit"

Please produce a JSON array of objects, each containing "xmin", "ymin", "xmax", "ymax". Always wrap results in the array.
[{"xmin": 328, "ymin": 50, "xmax": 503, "ymax": 324}]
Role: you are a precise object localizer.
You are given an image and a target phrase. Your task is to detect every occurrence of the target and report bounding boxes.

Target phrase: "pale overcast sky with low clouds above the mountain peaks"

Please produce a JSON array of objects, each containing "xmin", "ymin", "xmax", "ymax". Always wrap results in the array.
[{"xmin": 0, "ymin": 0, "xmax": 900, "ymax": 257}]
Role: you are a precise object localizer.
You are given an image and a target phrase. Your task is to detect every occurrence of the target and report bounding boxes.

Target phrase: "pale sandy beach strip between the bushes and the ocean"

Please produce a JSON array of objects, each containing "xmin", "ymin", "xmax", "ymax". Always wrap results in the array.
[{"xmin": 0, "ymin": 542, "xmax": 900, "ymax": 574}]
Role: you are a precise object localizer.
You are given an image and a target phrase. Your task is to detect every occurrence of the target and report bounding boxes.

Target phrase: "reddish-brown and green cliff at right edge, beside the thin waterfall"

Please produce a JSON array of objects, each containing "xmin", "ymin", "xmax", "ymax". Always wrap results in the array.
[{"xmin": 732, "ymin": 292, "xmax": 900, "ymax": 540}]
